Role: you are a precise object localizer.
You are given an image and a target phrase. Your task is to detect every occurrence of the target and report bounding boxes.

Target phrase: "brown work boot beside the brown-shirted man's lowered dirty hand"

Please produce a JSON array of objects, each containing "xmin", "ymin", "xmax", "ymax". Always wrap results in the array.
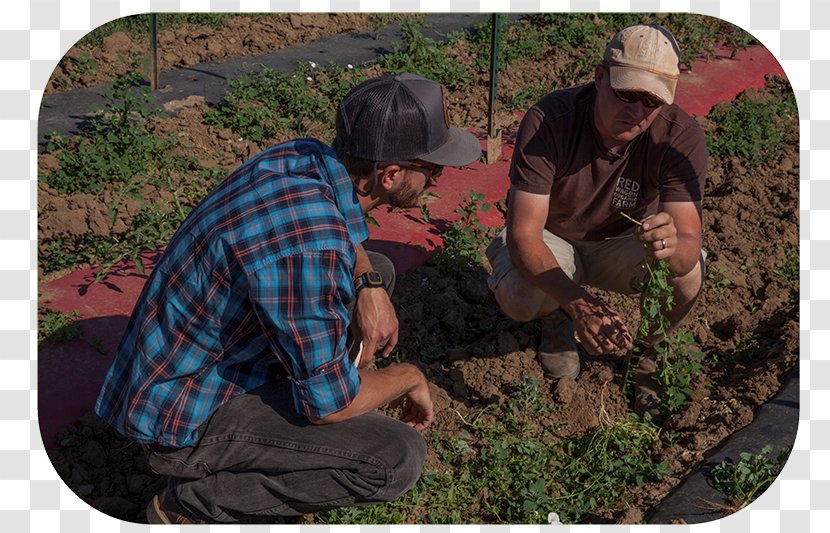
[{"xmin": 537, "ymin": 309, "xmax": 579, "ymax": 379}]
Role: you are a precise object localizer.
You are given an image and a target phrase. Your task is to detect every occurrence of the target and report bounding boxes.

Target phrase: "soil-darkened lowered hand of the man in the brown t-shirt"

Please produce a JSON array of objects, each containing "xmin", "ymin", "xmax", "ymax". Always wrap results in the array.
[{"xmin": 562, "ymin": 292, "xmax": 633, "ymax": 355}]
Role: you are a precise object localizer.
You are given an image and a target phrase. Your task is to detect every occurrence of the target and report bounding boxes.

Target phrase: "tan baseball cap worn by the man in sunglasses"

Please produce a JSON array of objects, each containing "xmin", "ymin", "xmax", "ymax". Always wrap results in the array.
[{"xmin": 604, "ymin": 24, "xmax": 680, "ymax": 104}]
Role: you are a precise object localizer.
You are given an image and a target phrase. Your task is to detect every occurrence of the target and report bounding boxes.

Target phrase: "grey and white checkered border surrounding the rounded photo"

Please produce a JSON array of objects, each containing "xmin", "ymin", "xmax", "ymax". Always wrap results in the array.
[{"xmin": 0, "ymin": 0, "xmax": 830, "ymax": 533}]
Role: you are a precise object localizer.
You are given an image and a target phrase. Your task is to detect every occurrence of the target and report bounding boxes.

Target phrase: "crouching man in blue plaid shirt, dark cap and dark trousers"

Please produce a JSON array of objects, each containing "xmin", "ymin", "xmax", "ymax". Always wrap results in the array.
[{"xmin": 96, "ymin": 74, "xmax": 480, "ymax": 523}]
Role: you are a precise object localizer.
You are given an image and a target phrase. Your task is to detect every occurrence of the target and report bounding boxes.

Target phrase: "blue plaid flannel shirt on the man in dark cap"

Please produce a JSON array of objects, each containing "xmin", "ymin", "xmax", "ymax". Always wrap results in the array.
[{"xmin": 95, "ymin": 139, "xmax": 369, "ymax": 447}]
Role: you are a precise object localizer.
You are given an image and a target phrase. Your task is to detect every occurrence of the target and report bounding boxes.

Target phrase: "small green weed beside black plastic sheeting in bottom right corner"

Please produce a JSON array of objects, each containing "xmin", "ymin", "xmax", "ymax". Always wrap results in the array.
[{"xmin": 712, "ymin": 445, "xmax": 792, "ymax": 506}]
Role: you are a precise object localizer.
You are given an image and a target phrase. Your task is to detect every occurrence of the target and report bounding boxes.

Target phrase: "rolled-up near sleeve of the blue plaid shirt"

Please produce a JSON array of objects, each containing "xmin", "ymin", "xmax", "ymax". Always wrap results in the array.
[{"xmin": 250, "ymin": 250, "xmax": 360, "ymax": 418}]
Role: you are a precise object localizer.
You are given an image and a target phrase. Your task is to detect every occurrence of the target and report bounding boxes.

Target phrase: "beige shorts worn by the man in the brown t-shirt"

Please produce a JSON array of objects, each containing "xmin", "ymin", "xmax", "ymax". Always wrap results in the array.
[{"xmin": 486, "ymin": 228, "xmax": 647, "ymax": 294}]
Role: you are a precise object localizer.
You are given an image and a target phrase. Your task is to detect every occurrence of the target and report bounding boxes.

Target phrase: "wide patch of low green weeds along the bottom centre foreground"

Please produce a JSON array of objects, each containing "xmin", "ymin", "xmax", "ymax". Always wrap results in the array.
[{"xmin": 314, "ymin": 378, "xmax": 669, "ymax": 524}]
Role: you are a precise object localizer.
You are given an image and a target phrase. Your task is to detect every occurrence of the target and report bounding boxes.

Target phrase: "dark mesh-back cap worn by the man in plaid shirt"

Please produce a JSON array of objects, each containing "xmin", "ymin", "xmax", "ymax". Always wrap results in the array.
[{"xmin": 336, "ymin": 73, "xmax": 481, "ymax": 167}]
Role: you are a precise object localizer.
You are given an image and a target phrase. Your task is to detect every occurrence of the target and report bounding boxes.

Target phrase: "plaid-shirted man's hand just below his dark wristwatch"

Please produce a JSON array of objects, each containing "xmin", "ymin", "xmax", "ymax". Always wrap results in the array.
[{"xmin": 350, "ymin": 287, "xmax": 398, "ymax": 368}]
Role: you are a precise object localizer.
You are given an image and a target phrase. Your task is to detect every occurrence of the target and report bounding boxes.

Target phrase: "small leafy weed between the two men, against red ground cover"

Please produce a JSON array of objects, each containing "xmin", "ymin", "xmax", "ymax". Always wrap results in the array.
[{"xmin": 433, "ymin": 189, "xmax": 490, "ymax": 274}]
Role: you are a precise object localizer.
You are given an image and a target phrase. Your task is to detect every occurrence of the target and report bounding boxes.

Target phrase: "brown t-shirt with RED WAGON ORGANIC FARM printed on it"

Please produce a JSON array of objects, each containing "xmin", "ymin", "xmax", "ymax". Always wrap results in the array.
[{"xmin": 510, "ymin": 84, "xmax": 707, "ymax": 241}]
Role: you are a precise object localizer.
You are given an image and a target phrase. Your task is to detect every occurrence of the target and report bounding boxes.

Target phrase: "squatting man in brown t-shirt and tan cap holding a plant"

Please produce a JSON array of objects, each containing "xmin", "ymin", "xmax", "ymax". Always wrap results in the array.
[{"xmin": 487, "ymin": 26, "xmax": 707, "ymax": 414}]
